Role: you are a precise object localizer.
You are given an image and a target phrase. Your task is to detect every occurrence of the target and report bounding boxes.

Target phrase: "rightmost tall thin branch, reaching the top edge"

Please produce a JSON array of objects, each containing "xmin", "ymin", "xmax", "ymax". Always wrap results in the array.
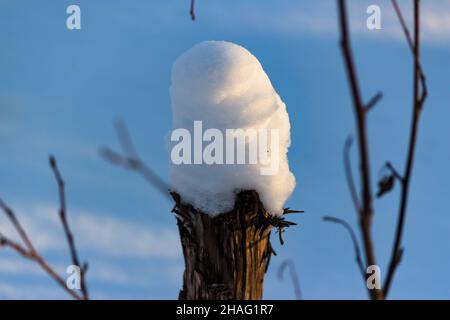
[{"xmin": 384, "ymin": 0, "xmax": 427, "ymax": 296}]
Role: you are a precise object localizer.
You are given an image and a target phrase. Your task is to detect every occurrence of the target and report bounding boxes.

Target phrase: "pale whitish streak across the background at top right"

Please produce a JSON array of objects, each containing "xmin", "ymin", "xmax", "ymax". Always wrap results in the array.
[{"xmin": 199, "ymin": 0, "xmax": 450, "ymax": 45}]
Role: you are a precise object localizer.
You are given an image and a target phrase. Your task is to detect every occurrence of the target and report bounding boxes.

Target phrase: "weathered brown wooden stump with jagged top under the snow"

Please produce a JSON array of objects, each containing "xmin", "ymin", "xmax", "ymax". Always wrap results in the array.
[{"xmin": 172, "ymin": 191, "xmax": 273, "ymax": 300}]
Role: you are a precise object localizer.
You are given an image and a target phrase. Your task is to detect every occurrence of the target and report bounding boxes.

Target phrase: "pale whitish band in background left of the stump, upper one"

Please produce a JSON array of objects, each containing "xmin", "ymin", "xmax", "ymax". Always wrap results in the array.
[{"xmin": 0, "ymin": 205, "xmax": 181, "ymax": 259}]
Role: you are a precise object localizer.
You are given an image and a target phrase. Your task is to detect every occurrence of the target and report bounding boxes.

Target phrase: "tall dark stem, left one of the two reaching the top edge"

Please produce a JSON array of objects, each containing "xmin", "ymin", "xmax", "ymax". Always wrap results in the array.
[{"xmin": 337, "ymin": 0, "xmax": 383, "ymax": 299}]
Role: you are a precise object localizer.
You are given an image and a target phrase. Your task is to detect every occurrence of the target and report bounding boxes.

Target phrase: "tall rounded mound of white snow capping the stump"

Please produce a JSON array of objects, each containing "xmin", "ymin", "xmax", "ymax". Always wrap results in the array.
[{"xmin": 170, "ymin": 41, "xmax": 295, "ymax": 215}]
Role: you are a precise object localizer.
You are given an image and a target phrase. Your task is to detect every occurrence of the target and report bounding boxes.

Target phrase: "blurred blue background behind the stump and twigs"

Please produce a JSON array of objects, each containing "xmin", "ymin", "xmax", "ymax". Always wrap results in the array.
[{"xmin": 0, "ymin": 0, "xmax": 450, "ymax": 299}]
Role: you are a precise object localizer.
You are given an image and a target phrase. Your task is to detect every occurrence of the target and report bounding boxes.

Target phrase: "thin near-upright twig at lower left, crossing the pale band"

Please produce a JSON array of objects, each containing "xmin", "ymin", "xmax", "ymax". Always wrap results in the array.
[{"xmin": 49, "ymin": 156, "xmax": 89, "ymax": 300}]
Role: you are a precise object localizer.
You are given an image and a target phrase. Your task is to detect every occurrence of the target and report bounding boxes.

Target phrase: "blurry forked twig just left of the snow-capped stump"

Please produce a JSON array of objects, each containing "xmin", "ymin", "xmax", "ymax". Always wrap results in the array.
[{"xmin": 100, "ymin": 121, "xmax": 172, "ymax": 201}]
